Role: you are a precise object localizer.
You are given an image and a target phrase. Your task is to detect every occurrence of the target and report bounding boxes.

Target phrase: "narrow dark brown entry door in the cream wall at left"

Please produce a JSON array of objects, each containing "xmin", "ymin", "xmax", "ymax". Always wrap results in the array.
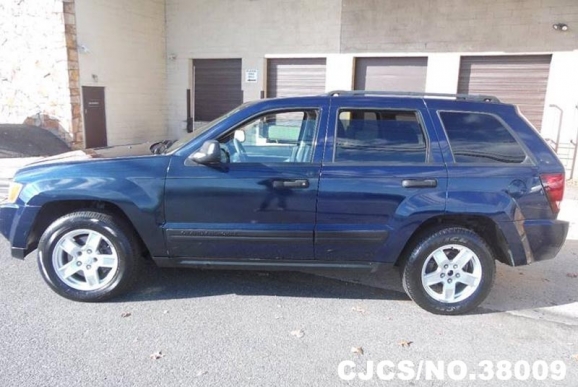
[{"xmin": 82, "ymin": 86, "xmax": 107, "ymax": 148}]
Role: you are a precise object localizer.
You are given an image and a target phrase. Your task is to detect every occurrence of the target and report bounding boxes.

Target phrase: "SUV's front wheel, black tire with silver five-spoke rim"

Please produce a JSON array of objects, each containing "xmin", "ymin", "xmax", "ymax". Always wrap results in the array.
[{"xmin": 38, "ymin": 211, "xmax": 143, "ymax": 302}]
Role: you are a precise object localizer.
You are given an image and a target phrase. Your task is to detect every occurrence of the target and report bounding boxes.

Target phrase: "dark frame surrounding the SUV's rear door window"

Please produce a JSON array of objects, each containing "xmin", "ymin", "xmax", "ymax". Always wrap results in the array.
[{"xmin": 328, "ymin": 106, "xmax": 432, "ymax": 166}]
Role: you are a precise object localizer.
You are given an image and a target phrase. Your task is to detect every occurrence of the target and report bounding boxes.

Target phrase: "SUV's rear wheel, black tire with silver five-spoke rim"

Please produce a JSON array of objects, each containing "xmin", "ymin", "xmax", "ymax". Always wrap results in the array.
[{"xmin": 401, "ymin": 227, "xmax": 496, "ymax": 315}]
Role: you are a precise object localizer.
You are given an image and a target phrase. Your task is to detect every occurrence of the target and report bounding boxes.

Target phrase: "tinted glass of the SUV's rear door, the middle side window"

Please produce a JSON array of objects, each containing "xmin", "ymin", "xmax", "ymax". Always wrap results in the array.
[{"xmin": 335, "ymin": 110, "xmax": 426, "ymax": 163}]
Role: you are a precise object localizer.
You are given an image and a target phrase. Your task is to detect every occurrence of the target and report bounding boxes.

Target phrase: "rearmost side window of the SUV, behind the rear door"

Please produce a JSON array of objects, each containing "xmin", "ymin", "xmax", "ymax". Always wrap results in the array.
[{"xmin": 439, "ymin": 112, "xmax": 526, "ymax": 164}]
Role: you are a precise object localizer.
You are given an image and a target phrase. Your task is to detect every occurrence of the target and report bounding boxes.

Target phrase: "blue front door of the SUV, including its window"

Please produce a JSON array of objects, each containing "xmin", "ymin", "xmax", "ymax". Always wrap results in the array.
[{"xmin": 165, "ymin": 104, "xmax": 326, "ymax": 260}]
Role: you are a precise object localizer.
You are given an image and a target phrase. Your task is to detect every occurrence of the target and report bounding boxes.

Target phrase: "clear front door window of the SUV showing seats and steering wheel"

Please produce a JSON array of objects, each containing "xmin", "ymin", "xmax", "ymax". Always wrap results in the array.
[{"xmin": 219, "ymin": 110, "xmax": 319, "ymax": 163}]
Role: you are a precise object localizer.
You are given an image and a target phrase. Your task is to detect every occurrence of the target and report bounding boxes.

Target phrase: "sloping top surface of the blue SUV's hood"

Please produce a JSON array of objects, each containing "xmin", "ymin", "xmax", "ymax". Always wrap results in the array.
[{"xmin": 28, "ymin": 142, "xmax": 152, "ymax": 165}]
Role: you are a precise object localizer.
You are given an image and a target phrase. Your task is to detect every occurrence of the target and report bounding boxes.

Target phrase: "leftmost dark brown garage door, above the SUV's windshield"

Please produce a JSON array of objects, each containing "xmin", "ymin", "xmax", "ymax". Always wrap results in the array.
[{"xmin": 193, "ymin": 59, "xmax": 243, "ymax": 121}]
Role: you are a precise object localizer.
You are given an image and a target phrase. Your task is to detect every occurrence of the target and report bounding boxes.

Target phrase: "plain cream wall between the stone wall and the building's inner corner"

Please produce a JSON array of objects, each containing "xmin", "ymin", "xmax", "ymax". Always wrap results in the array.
[{"xmin": 76, "ymin": 0, "xmax": 166, "ymax": 145}]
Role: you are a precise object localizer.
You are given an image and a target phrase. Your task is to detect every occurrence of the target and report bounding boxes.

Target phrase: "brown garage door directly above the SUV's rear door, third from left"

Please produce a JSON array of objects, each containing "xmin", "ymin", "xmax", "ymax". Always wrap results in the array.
[{"xmin": 355, "ymin": 57, "xmax": 427, "ymax": 92}]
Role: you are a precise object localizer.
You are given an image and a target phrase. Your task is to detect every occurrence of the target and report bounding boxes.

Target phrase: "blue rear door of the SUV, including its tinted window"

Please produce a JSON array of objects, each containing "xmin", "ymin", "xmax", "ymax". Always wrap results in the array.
[{"xmin": 315, "ymin": 97, "xmax": 447, "ymax": 262}]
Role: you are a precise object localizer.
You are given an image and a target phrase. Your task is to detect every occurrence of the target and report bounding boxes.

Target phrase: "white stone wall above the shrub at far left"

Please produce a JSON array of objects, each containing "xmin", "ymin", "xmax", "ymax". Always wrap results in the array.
[{"xmin": 0, "ymin": 0, "xmax": 76, "ymax": 143}]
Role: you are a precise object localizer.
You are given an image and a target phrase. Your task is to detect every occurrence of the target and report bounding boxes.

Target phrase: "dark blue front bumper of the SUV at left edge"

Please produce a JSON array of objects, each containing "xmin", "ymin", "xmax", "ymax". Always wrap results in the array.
[{"xmin": 0, "ymin": 203, "xmax": 40, "ymax": 259}]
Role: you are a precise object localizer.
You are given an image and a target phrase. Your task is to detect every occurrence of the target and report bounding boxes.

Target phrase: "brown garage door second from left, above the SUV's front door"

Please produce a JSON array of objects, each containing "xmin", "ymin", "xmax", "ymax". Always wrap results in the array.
[{"xmin": 267, "ymin": 58, "xmax": 325, "ymax": 98}]
